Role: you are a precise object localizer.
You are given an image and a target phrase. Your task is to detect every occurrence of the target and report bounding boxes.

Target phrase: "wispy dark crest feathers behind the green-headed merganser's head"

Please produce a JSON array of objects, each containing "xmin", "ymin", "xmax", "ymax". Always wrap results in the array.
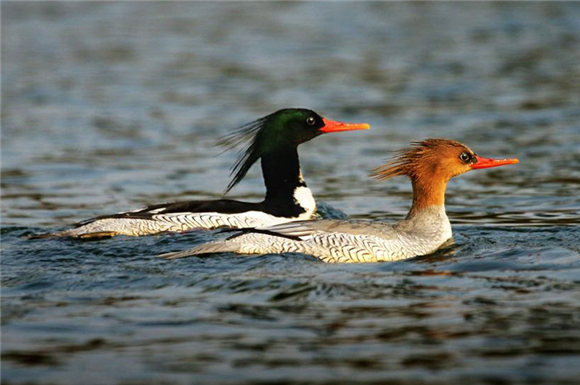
[{"xmin": 217, "ymin": 115, "xmax": 270, "ymax": 194}]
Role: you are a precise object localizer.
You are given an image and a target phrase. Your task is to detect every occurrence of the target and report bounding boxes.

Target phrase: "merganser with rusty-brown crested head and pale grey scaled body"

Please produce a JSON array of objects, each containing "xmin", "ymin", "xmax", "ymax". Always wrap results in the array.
[{"xmin": 161, "ymin": 139, "xmax": 519, "ymax": 263}]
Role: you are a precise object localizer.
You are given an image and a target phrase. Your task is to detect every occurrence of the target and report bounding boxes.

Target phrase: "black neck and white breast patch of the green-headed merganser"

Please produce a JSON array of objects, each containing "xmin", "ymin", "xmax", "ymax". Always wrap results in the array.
[{"xmin": 261, "ymin": 148, "xmax": 315, "ymax": 216}]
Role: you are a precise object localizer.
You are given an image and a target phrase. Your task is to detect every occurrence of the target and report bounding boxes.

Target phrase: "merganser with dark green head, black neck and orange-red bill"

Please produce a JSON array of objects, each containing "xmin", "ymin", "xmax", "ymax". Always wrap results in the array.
[{"xmin": 38, "ymin": 108, "xmax": 370, "ymax": 238}]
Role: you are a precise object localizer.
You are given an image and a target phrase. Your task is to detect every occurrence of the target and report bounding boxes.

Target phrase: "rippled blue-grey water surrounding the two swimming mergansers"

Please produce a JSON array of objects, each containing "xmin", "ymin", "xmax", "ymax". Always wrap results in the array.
[{"xmin": 2, "ymin": 2, "xmax": 580, "ymax": 384}]
